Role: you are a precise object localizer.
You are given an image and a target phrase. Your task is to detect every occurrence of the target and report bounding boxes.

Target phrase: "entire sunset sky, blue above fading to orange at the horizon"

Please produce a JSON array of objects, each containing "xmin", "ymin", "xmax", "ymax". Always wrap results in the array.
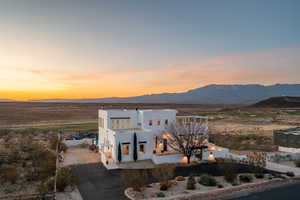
[{"xmin": 0, "ymin": 0, "xmax": 300, "ymax": 100}]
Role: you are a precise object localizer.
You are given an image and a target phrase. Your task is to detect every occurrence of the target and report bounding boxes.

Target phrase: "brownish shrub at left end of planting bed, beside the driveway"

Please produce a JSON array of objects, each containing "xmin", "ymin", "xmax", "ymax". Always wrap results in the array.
[{"xmin": 121, "ymin": 169, "xmax": 148, "ymax": 191}]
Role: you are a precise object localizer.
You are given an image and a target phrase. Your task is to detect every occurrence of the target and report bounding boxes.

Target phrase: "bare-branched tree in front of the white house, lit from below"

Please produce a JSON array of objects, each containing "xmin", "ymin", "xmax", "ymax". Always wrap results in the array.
[{"xmin": 162, "ymin": 122, "xmax": 208, "ymax": 164}]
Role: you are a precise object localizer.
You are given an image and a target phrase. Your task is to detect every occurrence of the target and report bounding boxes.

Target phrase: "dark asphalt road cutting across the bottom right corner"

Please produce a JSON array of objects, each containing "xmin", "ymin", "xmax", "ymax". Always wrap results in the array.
[{"xmin": 232, "ymin": 184, "xmax": 300, "ymax": 200}]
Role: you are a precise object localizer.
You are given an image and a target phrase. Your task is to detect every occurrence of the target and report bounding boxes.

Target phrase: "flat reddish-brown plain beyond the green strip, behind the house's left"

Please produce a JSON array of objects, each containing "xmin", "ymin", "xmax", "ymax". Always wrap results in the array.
[{"xmin": 0, "ymin": 102, "xmax": 225, "ymax": 126}]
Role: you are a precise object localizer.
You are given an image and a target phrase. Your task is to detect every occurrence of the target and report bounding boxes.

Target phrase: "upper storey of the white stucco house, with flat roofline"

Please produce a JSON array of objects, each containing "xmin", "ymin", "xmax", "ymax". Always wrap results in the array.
[{"xmin": 99, "ymin": 109, "xmax": 177, "ymax": 130}]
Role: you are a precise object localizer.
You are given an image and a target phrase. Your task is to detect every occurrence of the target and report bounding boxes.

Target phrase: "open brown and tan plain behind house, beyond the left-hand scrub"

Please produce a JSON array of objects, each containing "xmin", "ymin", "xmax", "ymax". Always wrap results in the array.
[{"xmin": 0, "ymin": 102, "xmax": 300, "ymax": 151}]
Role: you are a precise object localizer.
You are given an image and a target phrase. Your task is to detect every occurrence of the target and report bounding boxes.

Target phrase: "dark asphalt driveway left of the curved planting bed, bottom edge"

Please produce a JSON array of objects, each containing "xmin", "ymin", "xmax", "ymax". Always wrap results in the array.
[{"xmin": 74, "ymin": 163, "xmax": 127, "ymax": 200}]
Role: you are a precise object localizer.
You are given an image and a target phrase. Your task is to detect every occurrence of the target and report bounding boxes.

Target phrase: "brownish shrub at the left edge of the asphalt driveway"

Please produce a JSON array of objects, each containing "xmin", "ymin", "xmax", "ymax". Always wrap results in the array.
[{"xmin": 57, "ymin": 167, "xmax": 75, "ymax": 192}]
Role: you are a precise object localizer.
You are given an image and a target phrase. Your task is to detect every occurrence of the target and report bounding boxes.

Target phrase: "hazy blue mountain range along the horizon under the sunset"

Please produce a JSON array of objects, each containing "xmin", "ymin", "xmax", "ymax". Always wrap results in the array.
[{"xmin": 31, "ymin": 84, "xmax": 300, "ymax": 104}]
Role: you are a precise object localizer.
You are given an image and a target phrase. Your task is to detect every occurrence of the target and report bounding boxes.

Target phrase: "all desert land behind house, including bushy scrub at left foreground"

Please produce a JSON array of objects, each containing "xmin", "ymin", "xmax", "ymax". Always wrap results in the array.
[{"xmin": 0, "ymin": 102, "xmax": 300, "ymax": 196}]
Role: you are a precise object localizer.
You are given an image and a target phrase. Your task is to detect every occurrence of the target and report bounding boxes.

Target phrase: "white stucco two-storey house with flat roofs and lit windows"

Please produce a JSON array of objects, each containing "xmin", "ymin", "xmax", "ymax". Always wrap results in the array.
[{"xmin": 98, "ymin": 109, "xmax": 229, "ymax": 169}]
